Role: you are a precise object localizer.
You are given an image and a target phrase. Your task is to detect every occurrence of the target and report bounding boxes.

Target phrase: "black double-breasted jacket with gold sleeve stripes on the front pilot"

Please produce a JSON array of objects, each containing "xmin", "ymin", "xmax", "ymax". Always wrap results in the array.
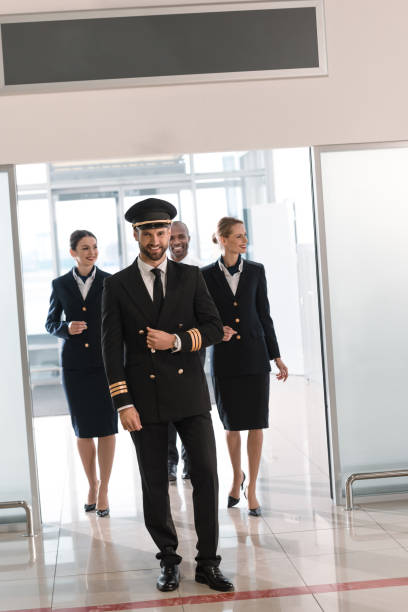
[{"xmin": 102, "ymin": 260, "xmax": 223, "ymax": 424}]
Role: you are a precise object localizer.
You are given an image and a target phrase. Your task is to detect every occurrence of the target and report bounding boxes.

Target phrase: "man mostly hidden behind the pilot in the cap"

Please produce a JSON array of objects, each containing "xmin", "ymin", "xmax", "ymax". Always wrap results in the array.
[{"xmin": 167, "ymin": 221, "xmax": 205, "ymax": 482}]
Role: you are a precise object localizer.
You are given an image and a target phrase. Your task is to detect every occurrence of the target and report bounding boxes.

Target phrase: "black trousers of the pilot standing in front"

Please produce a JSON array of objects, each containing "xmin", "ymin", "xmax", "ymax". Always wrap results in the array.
[{"xmin": 131, "ymin": 412, "xmax": 221, "ymax": 566}]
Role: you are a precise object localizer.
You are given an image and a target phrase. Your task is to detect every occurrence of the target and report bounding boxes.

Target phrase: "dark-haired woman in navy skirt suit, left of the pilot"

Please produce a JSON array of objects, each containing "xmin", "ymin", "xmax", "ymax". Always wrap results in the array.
[{"xmin": 45, "ymin": 230, "xmax": 118, "ymax": 517}]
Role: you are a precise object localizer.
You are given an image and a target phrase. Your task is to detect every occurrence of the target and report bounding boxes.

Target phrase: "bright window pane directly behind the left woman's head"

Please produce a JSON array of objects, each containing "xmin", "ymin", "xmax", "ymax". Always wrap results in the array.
[{"xmin": 56, "ymin": 194, "xmax": 119, "ymax": 274}]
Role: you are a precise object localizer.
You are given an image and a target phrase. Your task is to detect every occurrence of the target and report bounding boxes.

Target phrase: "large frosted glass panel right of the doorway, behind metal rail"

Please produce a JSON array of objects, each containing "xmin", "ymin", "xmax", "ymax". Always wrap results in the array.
[{"xmin": 321, "ymin": 148, "xmax": 408, "ymax": 493}]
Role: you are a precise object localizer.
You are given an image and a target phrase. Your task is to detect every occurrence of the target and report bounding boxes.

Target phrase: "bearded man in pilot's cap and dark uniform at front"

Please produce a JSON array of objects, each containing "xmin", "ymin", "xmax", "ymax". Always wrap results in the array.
[{"xmin": 102, "ymin": 198, "xmax": 234, "ymax": 591}]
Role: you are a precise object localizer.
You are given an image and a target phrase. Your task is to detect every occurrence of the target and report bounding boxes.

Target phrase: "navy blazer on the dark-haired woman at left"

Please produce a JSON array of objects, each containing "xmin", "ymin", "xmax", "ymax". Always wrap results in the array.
[{"xmin": 45, "ymin": 268, "xmax": 110, "ymax": 370}]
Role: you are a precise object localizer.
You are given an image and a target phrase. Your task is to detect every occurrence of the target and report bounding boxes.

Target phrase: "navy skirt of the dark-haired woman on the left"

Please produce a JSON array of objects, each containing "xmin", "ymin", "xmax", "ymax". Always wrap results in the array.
[{"xmin": 62, "ymin": 367, "xmax": 118, "ymax": 438}]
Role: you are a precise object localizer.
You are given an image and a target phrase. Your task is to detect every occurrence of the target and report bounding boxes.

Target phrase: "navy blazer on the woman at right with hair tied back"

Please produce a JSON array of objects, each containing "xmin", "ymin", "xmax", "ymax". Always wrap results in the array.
[{"xmin": 202, "ymin": 260, "xmax": 280, "ymax": 378}]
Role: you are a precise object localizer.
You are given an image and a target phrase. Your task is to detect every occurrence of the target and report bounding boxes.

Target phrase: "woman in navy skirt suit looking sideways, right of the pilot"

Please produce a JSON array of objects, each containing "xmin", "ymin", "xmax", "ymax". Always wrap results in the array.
[{"xmin": 202, "ymin": 217, "xmax": 288, "ymax": 516}]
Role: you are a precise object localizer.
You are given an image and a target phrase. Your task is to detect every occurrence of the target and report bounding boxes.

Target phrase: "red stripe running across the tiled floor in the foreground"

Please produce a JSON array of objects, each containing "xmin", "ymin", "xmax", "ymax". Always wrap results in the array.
[{"xmin": 3, "ymin": 576, "xmax": 408, "ymax": 612}]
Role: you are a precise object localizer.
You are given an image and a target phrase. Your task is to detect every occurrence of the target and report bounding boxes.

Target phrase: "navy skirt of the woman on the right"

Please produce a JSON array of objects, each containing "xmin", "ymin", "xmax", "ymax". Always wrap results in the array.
[{"xmin": 213, "ymin": 372, "xmax": 270, "ymax": 431}]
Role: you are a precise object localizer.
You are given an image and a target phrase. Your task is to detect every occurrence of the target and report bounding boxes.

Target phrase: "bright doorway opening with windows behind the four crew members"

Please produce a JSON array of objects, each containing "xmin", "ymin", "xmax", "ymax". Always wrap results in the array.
[{"xmin": 17, "ymin": 148, "xmax": 329, "ymax": 520}]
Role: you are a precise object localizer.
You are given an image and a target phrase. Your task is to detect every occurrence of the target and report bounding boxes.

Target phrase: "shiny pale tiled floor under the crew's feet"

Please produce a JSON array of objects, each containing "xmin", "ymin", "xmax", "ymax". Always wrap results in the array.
[{"xmin": 0, "ymin": 377, "xmax": 408, "ymax": 612}]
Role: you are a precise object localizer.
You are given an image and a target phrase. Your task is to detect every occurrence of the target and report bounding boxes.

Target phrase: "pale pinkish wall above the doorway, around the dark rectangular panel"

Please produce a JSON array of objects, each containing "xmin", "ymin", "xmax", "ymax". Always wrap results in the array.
[{"xmin": 0, "ymin": 0, "xmax": 408, "ymax": 163}]
